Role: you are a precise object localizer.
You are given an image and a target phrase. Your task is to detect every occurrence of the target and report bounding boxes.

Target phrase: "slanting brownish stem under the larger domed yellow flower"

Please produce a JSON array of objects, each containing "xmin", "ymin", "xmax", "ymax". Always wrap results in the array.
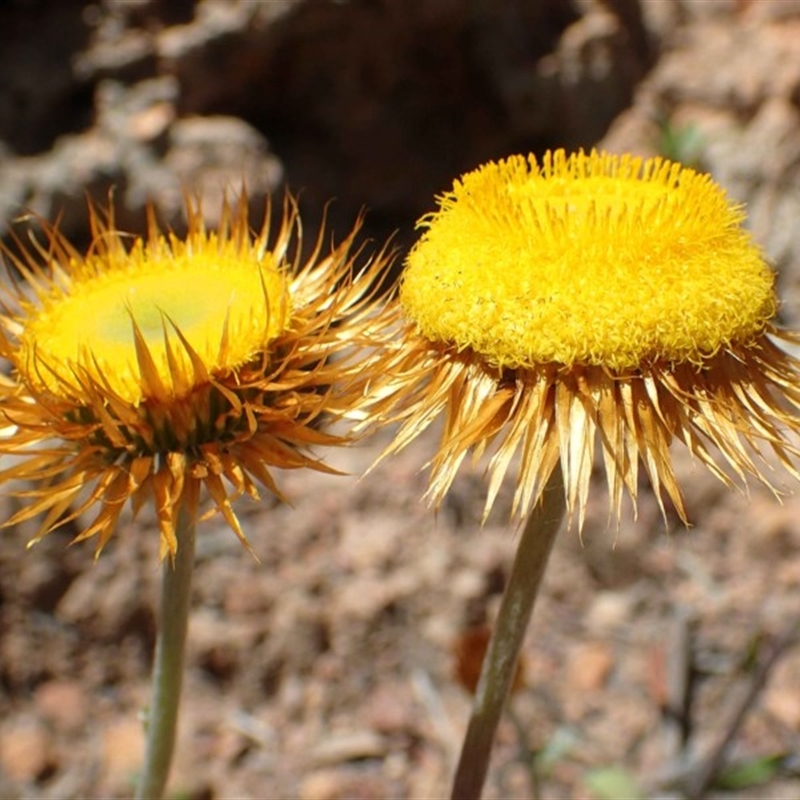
[{"xmin": 451, "ymin": 465, "xmax": 566, "ymax": 800}]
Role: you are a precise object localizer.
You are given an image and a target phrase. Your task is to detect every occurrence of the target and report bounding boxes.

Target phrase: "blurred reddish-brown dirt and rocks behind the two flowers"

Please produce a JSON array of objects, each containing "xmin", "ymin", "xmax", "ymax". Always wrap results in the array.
[{"xmin": 0, "ymin": 0, "xmax": 800, "ymax": 800}]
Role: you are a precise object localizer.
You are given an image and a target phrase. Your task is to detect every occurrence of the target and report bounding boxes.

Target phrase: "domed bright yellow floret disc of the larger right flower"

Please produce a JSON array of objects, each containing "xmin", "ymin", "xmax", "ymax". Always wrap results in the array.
[{"xmin": 401, "ymin": 151, "xmax": 777, "ymax": 370}]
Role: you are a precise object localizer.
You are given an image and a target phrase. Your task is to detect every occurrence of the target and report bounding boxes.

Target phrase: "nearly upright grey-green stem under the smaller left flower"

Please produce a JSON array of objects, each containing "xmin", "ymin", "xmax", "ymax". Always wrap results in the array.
[{"xmin": 136, "ymin": 510, "xmax": 195, "ymax": 800}]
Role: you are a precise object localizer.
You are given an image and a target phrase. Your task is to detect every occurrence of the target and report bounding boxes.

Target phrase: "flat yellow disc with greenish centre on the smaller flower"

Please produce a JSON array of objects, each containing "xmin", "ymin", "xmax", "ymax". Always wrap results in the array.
[{"xmin": 20, "ymin": 222, "xmax": 289, "ymax": 404}]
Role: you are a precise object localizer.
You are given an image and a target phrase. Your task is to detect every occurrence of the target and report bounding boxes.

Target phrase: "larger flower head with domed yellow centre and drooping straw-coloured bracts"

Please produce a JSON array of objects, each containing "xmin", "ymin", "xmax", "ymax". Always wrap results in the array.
[{"xmin": 372, "ymin": 150, "xmax": 800, "ymax": 527}]
